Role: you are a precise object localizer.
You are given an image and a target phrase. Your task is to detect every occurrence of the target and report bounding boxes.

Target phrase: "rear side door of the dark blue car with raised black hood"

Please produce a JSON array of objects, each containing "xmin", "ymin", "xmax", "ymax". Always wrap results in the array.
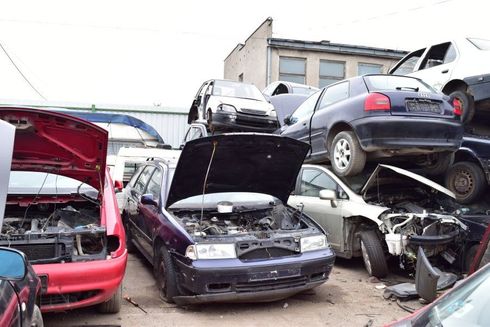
[{"xmin": 127, "ymin": 165, "xmax": 155, "ymax": 255}]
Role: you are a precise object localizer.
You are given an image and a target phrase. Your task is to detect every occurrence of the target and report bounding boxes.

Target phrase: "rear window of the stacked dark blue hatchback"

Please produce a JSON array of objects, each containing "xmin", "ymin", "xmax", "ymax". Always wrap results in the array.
[{"xmin": 364, "ymin": 75, "xmax": 436, "ymax": 93}]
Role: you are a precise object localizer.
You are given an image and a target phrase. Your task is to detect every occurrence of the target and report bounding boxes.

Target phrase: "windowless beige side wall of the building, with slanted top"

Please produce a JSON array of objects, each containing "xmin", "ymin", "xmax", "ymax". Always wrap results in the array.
[{"xmin": 223, "ymin": 18, "xmax": 272, "ymax": 90}]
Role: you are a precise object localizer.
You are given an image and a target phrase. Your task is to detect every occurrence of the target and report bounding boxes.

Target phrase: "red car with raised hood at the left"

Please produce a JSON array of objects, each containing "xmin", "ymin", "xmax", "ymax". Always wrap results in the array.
[{"xmin": 0, "ymin": 107, "xmax": 127, "ymax": 313}]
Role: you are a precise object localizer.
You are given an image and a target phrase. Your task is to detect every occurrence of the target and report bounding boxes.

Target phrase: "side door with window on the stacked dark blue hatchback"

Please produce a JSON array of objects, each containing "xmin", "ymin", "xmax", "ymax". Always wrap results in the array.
[{"xmin": 281, "ymin": 91, "xmax": 322, "ymax": 143}]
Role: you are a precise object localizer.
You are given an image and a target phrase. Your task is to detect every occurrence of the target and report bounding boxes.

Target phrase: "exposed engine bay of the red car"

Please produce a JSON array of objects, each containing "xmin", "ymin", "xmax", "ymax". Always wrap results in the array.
[{"xmin": 0, "ymin": 201, "xmax": 107, "ymax": 263}]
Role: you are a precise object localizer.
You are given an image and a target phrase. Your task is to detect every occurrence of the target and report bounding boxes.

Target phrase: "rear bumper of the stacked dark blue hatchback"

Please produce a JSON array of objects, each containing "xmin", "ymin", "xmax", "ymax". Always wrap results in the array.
[{"xmin": 351, "ymin": 116, "xmax": 463, "ymax": 153}]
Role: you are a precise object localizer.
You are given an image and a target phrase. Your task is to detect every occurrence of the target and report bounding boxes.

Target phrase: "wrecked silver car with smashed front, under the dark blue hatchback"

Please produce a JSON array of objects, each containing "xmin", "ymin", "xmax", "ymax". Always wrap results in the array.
[{"xmin": 288, "ymin": 165, "xmax": 470, "ymax": 277}]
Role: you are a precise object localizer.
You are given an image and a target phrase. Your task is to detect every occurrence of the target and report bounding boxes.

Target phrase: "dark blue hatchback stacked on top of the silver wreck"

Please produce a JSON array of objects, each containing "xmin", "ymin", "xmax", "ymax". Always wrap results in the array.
[{"xmin": 280, "ymin": 75, "xmax": 463, "ymax": 176}]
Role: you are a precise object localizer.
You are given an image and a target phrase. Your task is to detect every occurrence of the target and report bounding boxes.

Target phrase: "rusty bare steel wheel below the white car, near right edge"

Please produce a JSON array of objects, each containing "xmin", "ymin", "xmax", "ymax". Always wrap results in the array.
[{"xmin": 446, "ymin": 161, "xmax": 486, "ymax": 204}]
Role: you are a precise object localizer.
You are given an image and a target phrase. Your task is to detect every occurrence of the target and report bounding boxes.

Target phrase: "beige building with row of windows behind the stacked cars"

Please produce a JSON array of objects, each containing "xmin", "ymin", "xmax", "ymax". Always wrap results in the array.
[{"xmin": 224, "ymin": 18, "xmax": 407, "ymax": 90}]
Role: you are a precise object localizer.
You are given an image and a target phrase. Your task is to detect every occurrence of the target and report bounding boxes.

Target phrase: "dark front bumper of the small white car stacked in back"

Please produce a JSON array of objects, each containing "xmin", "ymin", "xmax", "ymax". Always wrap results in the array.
[{"xmin": 213, "ymin": 111, "xmax": 279, "ymax": 132}]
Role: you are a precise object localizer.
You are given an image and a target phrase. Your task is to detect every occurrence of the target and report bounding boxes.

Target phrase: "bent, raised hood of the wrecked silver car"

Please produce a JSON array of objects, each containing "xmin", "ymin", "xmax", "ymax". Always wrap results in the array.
[{"xmin": 361, "ymin": 164, "xmax": 456, "ymax": 199}]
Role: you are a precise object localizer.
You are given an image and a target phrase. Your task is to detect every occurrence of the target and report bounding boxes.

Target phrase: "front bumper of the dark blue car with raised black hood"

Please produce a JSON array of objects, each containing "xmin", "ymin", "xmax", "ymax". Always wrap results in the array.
[{"xmin": 170, "ymin": 248, "xmax": 335, "ymax": 305}]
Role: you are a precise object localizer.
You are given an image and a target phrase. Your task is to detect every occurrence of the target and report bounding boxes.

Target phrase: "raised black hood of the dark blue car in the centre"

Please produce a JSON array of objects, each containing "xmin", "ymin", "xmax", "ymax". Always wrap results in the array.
[{"xmin": 166, "ymin": 133, "xmax": 309, "ymax": 207}]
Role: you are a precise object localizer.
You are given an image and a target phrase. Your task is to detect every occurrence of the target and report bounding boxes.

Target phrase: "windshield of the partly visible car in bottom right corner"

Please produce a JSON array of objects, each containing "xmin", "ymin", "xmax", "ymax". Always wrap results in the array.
[{"xmin": 412, "ymin": 264, "xmax": 490, "ymax": 326}]
